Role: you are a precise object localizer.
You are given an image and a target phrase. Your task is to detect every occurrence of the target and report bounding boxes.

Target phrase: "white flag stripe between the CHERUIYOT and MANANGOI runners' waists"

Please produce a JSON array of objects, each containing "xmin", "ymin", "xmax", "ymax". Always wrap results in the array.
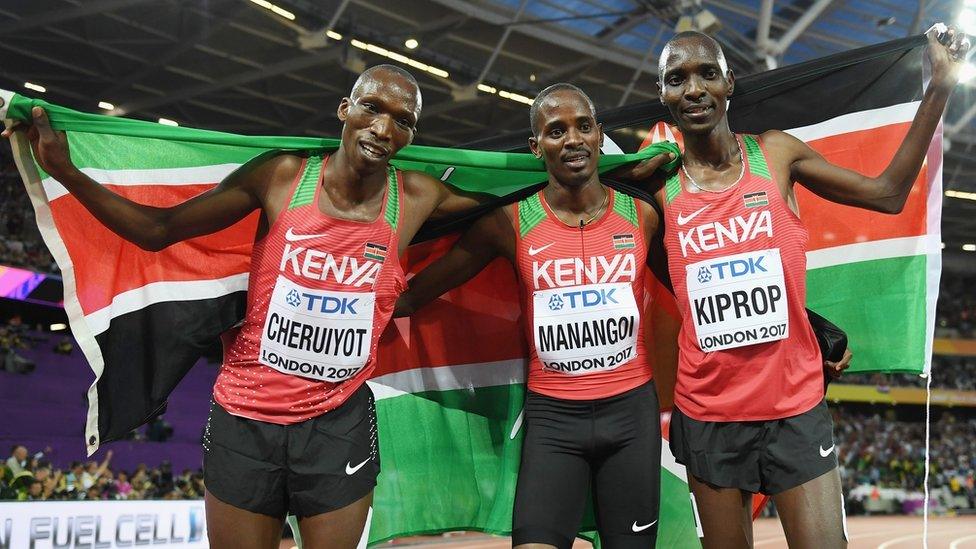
[{"xmin": 368, "ymin": 358, "xmax": 525, "ymax": 400}]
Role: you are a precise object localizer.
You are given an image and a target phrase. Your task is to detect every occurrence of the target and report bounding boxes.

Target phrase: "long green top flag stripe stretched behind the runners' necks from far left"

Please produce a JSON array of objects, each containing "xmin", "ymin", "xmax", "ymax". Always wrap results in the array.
[{"xmin": 7, "ymin": 94, "xmax": 680, "ymax": 196}]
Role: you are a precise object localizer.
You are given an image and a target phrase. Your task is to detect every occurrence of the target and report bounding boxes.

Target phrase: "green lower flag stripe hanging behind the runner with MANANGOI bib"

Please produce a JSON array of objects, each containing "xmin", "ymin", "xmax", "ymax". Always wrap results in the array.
[{"xmin": 369, "ymin": 383, "xmax": 700, "ymax": 548}]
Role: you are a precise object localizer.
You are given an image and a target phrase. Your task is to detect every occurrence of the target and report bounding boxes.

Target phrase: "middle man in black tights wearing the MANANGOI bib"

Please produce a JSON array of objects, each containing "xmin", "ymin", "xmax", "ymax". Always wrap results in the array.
[{"xmin": 394, "ymin": 84, "xmax": 673, "ymax": 549}]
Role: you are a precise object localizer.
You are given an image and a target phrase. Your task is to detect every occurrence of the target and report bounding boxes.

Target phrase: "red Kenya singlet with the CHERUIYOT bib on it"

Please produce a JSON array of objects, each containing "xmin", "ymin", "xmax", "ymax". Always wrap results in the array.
[{"xmin": 214, "ymin": 157, "xmax": 406, "ymax": 425}]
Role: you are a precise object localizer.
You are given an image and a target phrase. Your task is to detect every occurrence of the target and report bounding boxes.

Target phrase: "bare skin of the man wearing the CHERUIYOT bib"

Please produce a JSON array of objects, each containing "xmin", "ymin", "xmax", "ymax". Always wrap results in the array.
[{"xmin": 3, "ymin": 66, "xmax": 485, "ymax": 549}]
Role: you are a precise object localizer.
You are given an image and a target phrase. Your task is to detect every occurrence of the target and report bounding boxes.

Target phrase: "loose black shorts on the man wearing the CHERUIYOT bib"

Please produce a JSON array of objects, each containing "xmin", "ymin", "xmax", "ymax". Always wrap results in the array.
[{"xmin": 203, "ymin": 384, "xmax": 380, "ymax": 518}]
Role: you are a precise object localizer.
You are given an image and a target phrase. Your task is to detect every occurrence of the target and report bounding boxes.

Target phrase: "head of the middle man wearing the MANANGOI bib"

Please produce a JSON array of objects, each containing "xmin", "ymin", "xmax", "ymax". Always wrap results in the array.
[{"xmin": 529, "ymin": 89, "xmax": 603, "ymax": 186}]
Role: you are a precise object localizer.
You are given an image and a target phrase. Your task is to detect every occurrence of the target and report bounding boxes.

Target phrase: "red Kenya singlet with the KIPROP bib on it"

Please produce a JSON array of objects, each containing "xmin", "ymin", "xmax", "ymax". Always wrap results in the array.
[{"xmin": 664, "ymin": 135, "xmax": 824, "ymax": 421}]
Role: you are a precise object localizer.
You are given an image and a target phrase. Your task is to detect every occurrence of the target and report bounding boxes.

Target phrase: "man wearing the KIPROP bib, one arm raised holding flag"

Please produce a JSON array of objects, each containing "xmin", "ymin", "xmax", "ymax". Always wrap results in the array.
[{"xmin": 636, "ymin": 28, "xmax": 969, "ymax": 549}]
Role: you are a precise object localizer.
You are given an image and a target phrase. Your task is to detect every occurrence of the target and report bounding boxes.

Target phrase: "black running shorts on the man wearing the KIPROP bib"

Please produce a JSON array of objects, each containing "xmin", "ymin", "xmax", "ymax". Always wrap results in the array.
[{"xmin": 670, "ymin": 401, "xmax": 837, "ymax": 495}]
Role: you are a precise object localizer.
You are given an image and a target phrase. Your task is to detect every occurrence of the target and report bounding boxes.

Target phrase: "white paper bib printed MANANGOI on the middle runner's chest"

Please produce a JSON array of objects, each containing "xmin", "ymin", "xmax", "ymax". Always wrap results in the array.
[{"xmin": 532, "ymin": 282, "xmax": 641, "ymax": 375}]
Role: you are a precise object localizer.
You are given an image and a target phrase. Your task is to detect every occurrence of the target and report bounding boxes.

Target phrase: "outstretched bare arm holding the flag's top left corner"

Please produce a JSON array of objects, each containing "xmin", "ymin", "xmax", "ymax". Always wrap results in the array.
[{"xmin": 3, "ymin": 107, "xmax": 292, "ymax": 251}]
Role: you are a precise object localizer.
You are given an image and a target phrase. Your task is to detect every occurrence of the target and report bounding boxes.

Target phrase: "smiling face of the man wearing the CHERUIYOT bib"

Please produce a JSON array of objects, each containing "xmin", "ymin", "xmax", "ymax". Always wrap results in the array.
[{"xmin": 337, "ymin": 70, "xmax": 421, "ymax": 172}]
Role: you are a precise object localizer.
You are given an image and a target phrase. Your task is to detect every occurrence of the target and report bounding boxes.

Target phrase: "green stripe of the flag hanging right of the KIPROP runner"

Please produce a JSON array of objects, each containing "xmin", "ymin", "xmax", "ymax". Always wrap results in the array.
[{"xmin": 807, "ymin": 255, "xmax": 927, "ymax": 374}]
